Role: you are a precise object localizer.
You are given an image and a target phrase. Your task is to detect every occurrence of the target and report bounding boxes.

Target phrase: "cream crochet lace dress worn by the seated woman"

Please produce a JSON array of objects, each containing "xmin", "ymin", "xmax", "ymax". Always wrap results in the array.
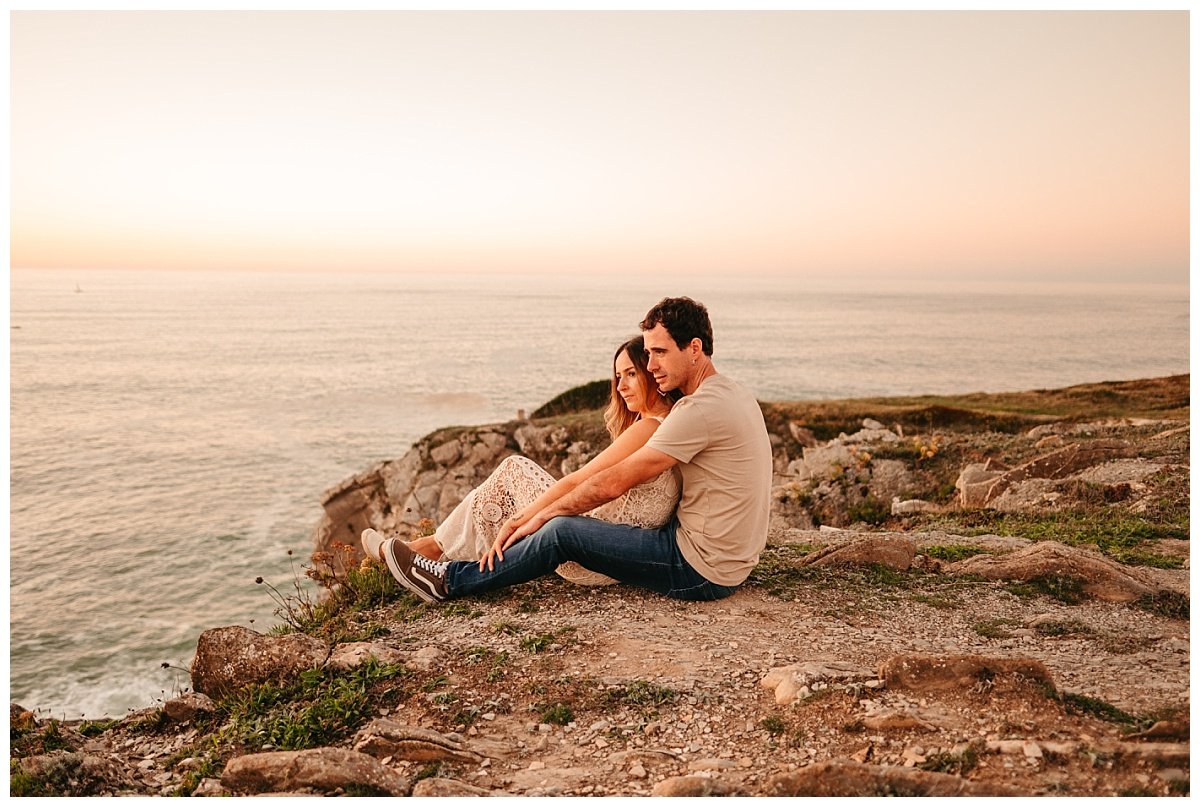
[{"xmin": 433, "ymin": 425, "xmax": 679, "ymax": 585}]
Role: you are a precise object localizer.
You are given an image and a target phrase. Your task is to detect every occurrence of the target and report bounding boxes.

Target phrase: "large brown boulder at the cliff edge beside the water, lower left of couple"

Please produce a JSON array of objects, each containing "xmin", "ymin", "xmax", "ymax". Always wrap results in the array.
[{"xmin": 192, "ymin": 624, "xmax": 329, "ymax": 699}]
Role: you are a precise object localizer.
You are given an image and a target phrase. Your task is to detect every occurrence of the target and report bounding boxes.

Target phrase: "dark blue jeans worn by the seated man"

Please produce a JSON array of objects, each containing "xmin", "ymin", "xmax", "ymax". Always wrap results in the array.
[{"xmin": 445, "ymin": 515, "xmax": 737, "ymax": 599}]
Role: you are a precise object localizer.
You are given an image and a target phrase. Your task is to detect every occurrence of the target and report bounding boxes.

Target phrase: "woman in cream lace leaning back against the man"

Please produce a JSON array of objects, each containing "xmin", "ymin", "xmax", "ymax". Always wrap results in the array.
[{"xmin": 362, "ymin": 336, "xmax": 679, "ymax": 586}]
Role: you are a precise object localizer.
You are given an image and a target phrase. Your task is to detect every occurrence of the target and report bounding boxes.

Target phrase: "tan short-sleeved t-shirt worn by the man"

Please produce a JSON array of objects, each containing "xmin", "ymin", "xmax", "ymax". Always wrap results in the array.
[{"xmin": 646, "ymin": 375, "xmax": 772, "ymax": 586}]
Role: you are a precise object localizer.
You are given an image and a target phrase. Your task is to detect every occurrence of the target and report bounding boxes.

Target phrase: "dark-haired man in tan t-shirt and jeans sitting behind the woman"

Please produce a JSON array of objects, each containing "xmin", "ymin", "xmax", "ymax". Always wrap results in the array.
[{"xmin": 362, "ymin": 297, "xmax": 772, "ymax": 602}]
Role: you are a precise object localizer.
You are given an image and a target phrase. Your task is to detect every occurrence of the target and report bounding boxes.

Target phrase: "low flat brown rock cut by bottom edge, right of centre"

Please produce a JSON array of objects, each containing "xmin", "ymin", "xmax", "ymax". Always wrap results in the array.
[{"xmin": 766, "ymin": 759, "xmax": 1018, "ymax": 796}]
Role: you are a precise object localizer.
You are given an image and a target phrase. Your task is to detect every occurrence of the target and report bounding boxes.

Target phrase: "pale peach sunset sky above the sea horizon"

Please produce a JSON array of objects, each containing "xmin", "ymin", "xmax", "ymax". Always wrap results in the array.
[{"xmin": 10, "ymin": 11, "xmax": 1189, "ymax": 283}]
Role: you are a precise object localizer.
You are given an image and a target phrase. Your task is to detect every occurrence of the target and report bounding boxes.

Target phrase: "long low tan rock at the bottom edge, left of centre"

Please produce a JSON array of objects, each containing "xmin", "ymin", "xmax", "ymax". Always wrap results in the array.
[{"xmin": 221, "ymin": 748, "xmax": 412, "ymax": 796}]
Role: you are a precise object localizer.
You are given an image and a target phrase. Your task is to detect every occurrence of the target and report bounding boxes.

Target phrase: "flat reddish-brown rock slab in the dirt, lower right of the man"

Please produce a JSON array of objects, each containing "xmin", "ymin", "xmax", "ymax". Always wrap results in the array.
[{"xmin": 878, "ymin": 653, "xmax": 1054, "ymax": 692}]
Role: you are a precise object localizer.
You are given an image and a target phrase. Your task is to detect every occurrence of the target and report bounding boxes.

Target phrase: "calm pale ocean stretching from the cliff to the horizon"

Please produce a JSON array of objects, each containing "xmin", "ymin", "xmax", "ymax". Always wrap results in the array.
[{"xmin": 10, "ymin": 269, "xmax": 1189, "ymax": 719}]
